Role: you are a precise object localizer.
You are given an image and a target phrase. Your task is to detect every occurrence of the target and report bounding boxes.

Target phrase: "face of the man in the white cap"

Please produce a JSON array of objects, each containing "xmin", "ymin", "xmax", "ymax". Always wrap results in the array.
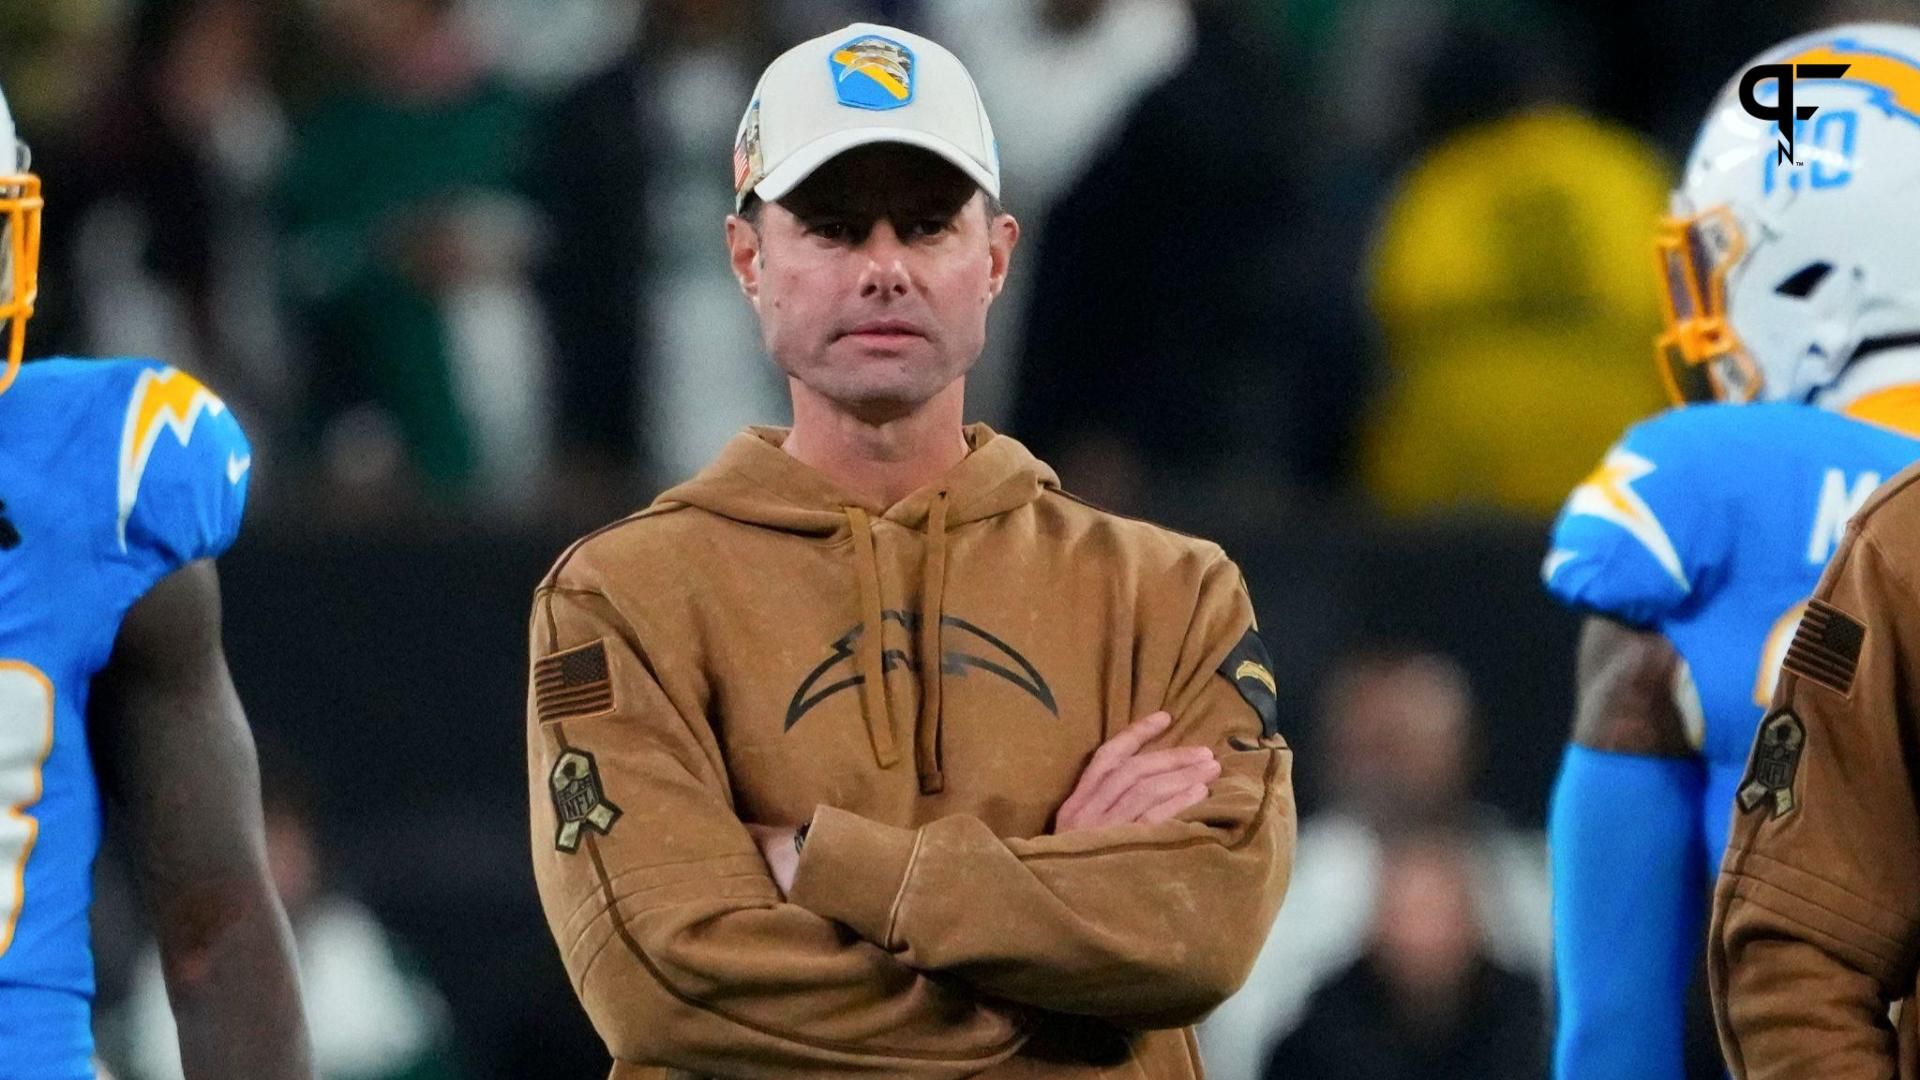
[{"xmin": 728, "ymin": 144, "xmax": 1020, "ymax": 421}]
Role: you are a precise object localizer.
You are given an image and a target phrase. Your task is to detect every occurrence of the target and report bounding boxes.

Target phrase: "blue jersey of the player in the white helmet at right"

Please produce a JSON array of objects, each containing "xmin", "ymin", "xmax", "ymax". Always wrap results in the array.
[{"xmin": 1542, "ymin": 404, "xmax": 1920, "ymax": 874}]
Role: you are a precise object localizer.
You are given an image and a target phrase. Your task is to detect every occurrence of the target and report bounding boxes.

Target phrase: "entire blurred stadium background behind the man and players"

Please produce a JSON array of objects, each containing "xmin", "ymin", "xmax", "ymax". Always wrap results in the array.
[{"xmin": 0, "ymin": 0, "xmax": 1910, "ymax": 1080}]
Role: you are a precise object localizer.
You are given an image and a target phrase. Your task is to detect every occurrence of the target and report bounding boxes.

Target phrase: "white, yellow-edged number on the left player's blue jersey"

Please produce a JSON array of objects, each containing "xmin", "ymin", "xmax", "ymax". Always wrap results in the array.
[{"xmin": 0, "ymin": 659, "xmax": 54, "ymax": 955}]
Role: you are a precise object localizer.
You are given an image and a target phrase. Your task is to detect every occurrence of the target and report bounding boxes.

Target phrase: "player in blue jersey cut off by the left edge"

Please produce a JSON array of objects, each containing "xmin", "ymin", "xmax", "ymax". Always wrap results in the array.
[{"xmin": 0, "ymin": 82, "xmax": 313, "ymax": 1080}]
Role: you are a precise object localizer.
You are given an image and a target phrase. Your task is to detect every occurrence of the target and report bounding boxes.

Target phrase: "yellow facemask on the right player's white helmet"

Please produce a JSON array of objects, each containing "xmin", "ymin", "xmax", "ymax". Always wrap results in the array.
[{"xmin": 1653, "ymin": 208, "xmax": 1763, "ymax": 404}]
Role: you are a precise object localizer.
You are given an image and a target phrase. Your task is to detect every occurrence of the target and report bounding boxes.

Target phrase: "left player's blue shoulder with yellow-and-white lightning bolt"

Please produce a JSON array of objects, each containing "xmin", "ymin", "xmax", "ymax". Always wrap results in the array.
[{"xmin": 108, "ymin": 359, "xmax": 253, "ymax": 573}]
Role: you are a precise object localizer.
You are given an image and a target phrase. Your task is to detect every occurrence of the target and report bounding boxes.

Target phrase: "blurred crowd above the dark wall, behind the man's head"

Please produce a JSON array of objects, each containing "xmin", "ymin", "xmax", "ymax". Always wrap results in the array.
[{"xmin": 22, "ymin": 0, "xmax": 1896, "ymax": 519}]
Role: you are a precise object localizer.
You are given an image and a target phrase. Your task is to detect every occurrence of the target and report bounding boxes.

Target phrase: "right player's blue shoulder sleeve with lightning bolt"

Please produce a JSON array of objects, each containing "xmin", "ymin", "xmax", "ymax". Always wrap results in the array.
[{"xmin": 1540, "ymin": 405, "xmax": 1753, "ymax": 626}]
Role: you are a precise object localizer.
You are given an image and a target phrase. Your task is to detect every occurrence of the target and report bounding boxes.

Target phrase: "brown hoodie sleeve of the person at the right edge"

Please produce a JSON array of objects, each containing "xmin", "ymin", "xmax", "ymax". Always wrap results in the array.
[{"xmin": 1707, "ymin": 457, "xmax": 1920, "ymax": 1080}]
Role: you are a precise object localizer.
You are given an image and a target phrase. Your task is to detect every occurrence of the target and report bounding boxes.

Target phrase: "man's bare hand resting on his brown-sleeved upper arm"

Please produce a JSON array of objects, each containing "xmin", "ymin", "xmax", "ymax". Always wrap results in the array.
[{"xmin": 1054, "ymin": 711, "xmax": 1219, "ymax": 834}]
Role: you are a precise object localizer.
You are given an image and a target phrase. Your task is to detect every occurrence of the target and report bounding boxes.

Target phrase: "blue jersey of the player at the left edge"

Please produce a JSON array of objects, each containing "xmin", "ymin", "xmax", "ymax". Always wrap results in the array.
[{"xmin": 0, "ymin": 359, "xmax": 252, "ymax": 1080}]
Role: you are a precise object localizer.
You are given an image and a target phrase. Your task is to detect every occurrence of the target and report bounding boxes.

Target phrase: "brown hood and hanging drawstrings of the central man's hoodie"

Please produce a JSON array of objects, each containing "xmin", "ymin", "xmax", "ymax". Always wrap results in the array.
[{"xmin": 653, "ymin": 425, "xmax": 1060, "ymax": 796}]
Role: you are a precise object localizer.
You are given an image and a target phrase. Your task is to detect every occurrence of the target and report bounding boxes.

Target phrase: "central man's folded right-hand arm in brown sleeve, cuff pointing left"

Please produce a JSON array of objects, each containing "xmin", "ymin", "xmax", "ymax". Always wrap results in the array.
[{"xmin": 791, "ymin": 557, "xmax": 1294, "ymax": 1028}]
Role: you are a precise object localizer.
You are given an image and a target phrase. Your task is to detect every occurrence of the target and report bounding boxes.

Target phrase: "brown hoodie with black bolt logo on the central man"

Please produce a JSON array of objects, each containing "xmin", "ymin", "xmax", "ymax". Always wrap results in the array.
[{"xmin": 528, "ymin": 425, "xmax": 1294, "ymax": 1080}]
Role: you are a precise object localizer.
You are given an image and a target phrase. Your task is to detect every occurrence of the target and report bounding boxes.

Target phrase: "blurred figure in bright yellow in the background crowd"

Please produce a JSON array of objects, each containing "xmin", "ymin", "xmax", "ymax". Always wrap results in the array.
[{"xmin": 1365, "ymin": 108, "xmax": 1668, "ymax": 515}]
